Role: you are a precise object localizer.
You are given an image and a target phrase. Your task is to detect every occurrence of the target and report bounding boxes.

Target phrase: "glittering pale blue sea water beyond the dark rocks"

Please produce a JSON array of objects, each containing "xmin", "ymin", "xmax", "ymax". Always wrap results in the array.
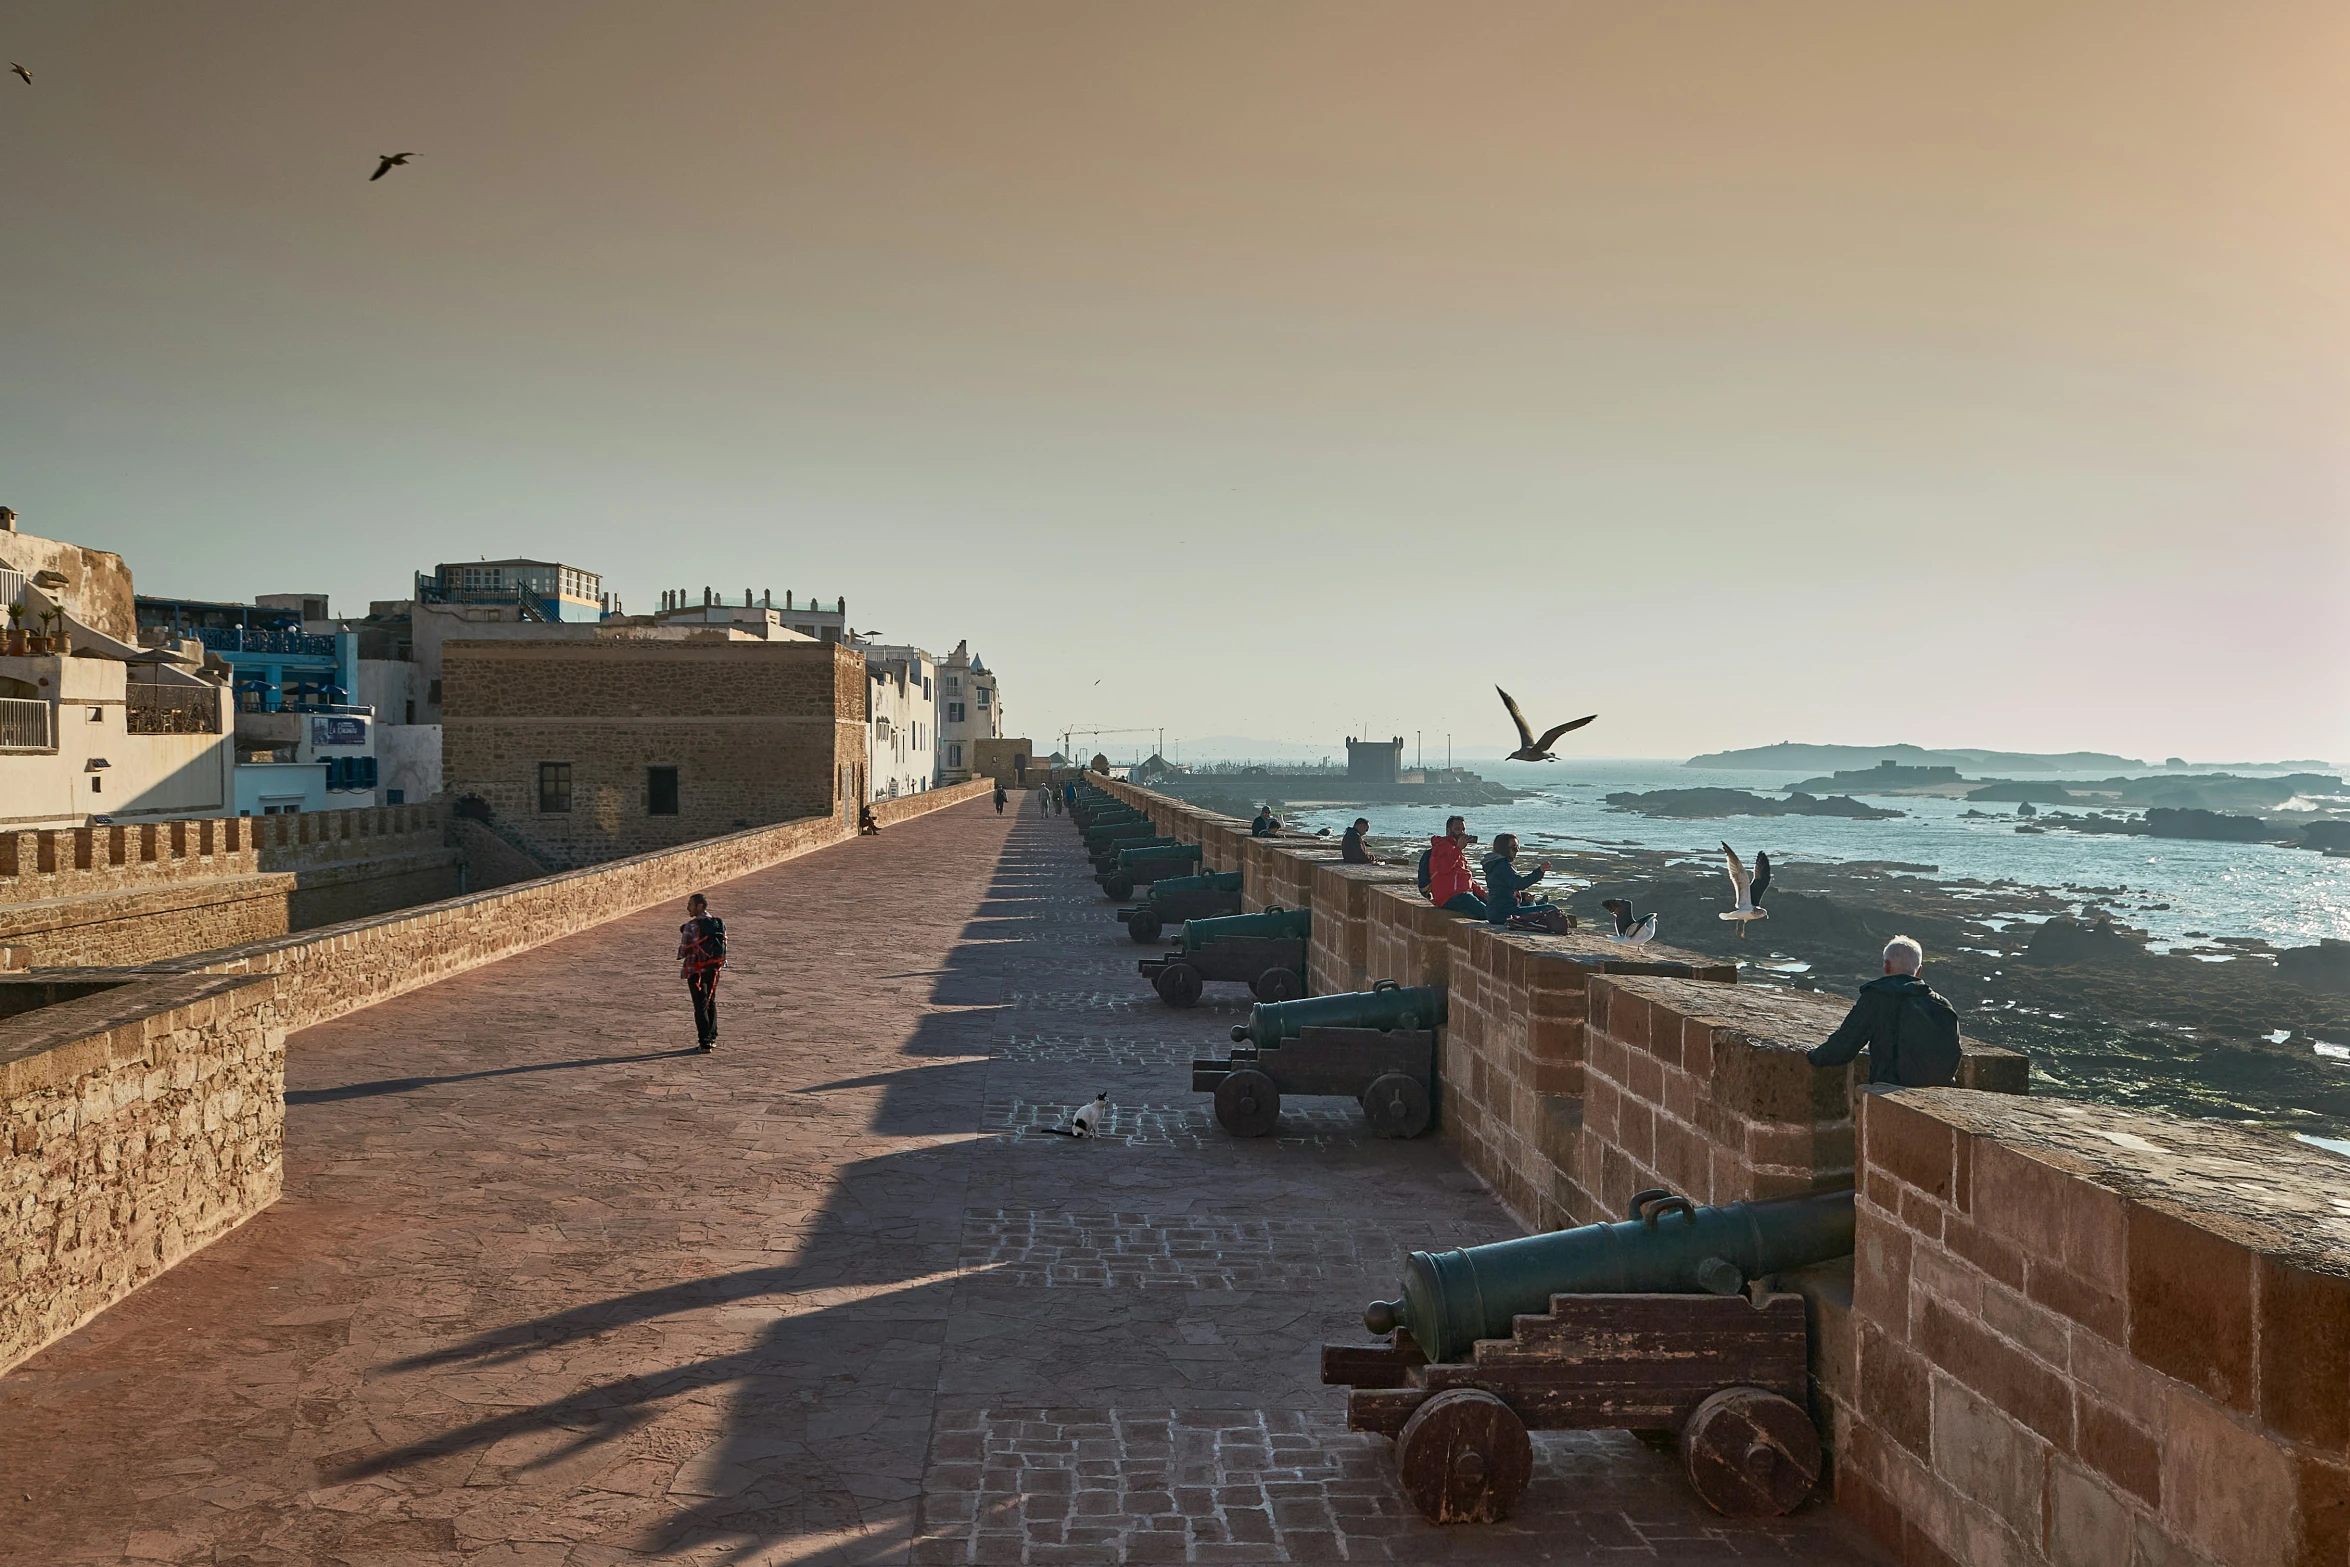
[{"xmin": 1287, "ymin": 759, "xmax": 2350, "ymax": 951}]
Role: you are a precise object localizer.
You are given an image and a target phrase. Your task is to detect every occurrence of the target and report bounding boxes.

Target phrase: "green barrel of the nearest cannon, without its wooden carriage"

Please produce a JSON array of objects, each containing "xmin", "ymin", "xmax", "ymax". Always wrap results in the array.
[{"xmin": 1363, "ymin": 1186, "xmax": 1852, "ymax": 1360}]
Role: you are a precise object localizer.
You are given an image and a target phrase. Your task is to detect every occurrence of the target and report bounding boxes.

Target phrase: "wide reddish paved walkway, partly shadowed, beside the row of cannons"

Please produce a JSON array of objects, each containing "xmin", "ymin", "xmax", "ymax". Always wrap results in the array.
[{"xmin": 0, "ymin": 801, "xmax": 1878, "ymax": 1567}]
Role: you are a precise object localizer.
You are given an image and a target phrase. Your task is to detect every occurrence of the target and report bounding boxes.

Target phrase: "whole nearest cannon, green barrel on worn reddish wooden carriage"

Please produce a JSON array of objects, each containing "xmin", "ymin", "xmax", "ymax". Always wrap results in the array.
[{"xmin": 1323, "ymin": 1189, "xmax": 1852, "ymax": 1522}]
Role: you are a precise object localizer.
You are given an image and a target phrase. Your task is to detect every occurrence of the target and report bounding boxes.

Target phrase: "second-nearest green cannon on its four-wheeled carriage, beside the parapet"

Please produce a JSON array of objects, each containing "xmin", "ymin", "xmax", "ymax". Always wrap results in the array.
[{"xmin": 1191, "ymin": 980, "xmax": 1445, "ymax": 1137}]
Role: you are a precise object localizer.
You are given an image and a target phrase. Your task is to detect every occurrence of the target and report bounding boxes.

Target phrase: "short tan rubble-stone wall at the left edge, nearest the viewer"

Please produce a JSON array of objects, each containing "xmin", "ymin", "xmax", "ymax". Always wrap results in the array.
[{"xmin": 0, "ymin": 975, "xmax": 287, "ymax": 1372}]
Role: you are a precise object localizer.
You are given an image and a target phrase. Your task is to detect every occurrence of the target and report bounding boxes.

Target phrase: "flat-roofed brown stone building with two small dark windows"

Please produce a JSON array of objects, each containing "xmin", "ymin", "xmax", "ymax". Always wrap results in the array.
[{"xmin": 442, "ymin": 625, "xmax": 870, "ymax": 869}]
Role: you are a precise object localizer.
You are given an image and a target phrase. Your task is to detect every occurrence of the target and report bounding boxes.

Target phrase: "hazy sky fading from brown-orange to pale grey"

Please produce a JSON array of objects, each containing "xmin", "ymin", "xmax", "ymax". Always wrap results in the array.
[{"xmin": 0, "ymin": 0, "xmax": 2350, "ymax": 759}]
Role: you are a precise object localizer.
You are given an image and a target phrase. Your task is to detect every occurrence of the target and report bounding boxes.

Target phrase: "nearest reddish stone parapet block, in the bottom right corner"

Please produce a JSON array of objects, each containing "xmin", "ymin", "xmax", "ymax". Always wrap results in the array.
[{"xmin": 1835, "ymin": 1090, "xmax": 2350, "ymax": 1567}]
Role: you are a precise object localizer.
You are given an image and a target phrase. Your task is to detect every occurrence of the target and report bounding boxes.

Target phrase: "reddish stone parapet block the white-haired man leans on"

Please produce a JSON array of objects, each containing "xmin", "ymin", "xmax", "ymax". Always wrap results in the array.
[{"xmin": 1572, "ymin": 975, "xmax": 2030, "ymax": 1222}]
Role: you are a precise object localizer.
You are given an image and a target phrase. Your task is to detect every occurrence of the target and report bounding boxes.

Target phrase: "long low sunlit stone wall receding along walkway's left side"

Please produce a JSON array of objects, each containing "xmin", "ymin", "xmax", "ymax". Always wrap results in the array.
[{"xmin": 172, "ymin": 780, "xmax": 994, "ymax": 1029}]
